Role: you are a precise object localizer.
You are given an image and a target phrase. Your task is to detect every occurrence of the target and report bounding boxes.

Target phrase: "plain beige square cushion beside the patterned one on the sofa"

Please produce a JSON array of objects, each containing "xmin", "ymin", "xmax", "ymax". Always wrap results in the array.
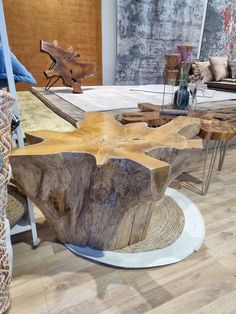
[{"xmin": 209, "ymin": 57, "xmax": 229, "ymax": 81}]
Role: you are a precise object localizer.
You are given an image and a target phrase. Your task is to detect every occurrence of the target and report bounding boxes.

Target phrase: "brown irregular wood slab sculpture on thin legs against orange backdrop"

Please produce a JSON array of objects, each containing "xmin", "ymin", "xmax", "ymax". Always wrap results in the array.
[{"xmin": 40, "ymin": 40, "xmax": 96, "ymax": 94}]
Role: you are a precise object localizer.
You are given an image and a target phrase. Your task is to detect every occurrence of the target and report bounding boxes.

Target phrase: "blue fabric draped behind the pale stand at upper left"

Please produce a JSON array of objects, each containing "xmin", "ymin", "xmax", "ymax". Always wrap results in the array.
[{"xmin": 0, "ymin": 46, "xmax": 36, "ymax": 87}]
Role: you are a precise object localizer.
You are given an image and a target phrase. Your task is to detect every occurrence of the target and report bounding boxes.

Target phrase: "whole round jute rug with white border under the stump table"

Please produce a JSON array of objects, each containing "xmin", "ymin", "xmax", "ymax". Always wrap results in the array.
[{"xmin": 65, "ymin": 188, "xmax": 205, "ymax": 269}]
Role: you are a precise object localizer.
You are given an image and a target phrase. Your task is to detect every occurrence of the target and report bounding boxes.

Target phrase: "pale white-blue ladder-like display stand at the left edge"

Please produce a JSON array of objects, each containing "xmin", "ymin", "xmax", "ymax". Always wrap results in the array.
[{"xmin": 0, "ymin": 0, "xmax": 40, "ymax": 247}]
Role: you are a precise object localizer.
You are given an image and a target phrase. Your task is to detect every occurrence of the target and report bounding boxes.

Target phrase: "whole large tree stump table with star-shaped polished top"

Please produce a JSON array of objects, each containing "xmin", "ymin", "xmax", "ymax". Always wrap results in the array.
[{"xmin": 11, "ymin": 112, "xmax": 202, "ymax": 250}]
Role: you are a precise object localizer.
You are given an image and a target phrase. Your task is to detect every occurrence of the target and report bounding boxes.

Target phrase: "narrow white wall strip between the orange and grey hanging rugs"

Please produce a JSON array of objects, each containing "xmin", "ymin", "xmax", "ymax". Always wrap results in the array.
[{"xmin": 102, "ymin": 0, "xmax": 116, "ymax": 85}]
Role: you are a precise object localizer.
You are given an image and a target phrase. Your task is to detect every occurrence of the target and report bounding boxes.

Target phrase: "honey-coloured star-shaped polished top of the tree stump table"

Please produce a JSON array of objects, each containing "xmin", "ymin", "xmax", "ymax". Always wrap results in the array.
[{"xmin": 12, "ymin": 112, "xmax": 202, "ymax": 168}]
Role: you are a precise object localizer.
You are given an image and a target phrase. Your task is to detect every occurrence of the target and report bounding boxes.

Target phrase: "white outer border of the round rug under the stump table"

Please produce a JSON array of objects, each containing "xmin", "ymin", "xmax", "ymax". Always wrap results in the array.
[{"xmin": 65, "ymin": 188, "xmax": 205, "ymax": 268}]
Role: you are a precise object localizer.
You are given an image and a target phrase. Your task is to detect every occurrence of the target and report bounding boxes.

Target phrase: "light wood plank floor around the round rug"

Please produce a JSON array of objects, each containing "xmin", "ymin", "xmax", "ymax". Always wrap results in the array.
[{"xmin": 9, "ymin": 149, "xmax": 236, "ymax": 314}]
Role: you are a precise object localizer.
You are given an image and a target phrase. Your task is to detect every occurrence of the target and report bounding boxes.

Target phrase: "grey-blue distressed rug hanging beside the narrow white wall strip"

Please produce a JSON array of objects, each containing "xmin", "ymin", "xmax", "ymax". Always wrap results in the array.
[{"xmin": 116, "ymin": 0, "xmax": 205, "ymax": 85}]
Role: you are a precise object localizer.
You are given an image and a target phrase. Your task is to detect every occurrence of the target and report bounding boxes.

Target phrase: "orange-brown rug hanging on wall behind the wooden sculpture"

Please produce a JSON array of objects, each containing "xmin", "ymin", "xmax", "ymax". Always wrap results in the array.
[{"xmin": 3, "ymin": 0, "xmax": 102, "ymax": 90}]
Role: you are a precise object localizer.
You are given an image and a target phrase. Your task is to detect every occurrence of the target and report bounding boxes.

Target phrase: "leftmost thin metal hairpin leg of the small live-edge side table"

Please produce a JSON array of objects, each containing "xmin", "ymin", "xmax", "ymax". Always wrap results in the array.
[{"xmin": 201, "ymin": 141, "xmax": 222, "ymax": 195}]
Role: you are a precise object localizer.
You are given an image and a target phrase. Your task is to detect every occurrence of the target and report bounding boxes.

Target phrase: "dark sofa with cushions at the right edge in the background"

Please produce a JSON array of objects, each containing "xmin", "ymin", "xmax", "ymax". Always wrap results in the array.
[{"xmin": 192, "ymin": 57, "xmax": 236, "ymax": 92}]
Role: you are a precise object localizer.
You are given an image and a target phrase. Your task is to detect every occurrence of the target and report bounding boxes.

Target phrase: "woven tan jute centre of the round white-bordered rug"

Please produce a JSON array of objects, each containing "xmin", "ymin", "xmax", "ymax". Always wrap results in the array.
[{"xmin": 115, "ymin": 196, "xmax": 184, "ymax": 253}]
